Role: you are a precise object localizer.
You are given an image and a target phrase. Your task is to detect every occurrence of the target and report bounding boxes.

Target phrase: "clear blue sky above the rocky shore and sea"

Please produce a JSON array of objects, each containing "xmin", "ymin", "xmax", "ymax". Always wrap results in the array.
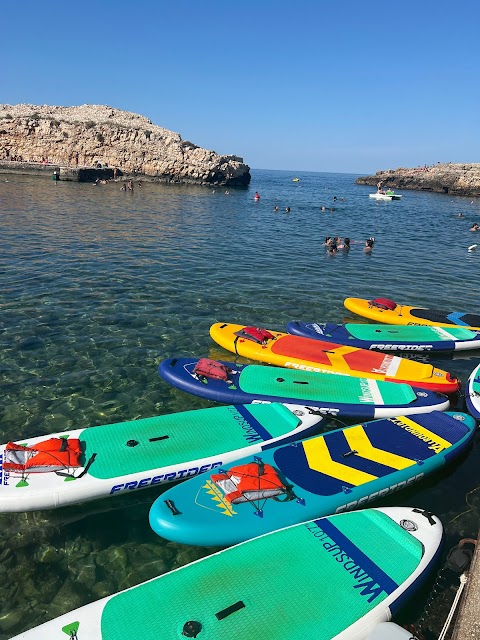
[{"xmin": 0, "ymin": 0, "xmax": 480, "ymax": 174}]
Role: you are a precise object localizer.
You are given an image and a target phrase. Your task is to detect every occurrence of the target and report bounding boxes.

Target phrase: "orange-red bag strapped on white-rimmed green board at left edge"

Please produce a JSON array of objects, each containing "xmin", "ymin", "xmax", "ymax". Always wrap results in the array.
[{"xmin": 3, "ymin": 438, "xmax": 83, "ymax": 473}]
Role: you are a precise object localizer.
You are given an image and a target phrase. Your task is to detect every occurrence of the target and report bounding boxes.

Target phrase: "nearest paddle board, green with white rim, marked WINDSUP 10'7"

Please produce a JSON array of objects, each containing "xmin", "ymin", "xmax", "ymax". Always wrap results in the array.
[{"xmin": 12, "ymin": 507, "xmax": 442, "ymax": 640}]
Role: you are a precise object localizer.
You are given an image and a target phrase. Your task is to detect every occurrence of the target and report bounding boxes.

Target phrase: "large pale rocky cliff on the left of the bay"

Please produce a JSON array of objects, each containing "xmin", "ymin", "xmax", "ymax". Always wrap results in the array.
[{"xmin": 0, "ymin": 104, "xmax": 250, "ymax": 186}]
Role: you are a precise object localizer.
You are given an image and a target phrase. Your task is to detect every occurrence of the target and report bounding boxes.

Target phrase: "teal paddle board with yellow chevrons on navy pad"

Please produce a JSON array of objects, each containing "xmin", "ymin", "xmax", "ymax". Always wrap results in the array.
[{"xmin": 150, "ymin": 412, "xmax": 476, "ymax": 546}]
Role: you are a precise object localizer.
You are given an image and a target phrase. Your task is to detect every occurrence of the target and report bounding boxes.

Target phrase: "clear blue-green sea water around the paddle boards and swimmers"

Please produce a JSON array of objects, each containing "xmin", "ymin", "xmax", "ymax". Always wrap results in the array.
[{"xmin": 0, "ymin": 171, "xmax": 480, "ymax": 640}]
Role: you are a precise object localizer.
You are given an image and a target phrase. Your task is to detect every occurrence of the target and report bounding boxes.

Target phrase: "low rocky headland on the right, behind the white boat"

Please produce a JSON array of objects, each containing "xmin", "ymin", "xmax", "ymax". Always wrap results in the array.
[{"xmin": 356, "ymin": 162, "xmax": 480, "ymax": 196}]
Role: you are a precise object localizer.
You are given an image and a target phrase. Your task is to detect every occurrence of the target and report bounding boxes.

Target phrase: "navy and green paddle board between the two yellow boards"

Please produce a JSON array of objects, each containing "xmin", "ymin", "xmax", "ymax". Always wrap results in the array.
[{"xmin": 287, "ymin": 321, "xmax": 480, "ymax": 353}]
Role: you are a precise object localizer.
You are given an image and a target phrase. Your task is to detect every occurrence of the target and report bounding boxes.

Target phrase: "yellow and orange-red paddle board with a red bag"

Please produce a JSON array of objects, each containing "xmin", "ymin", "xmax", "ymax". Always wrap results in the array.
[{"xmin": 210, "ymin": 322, "xmax": 459, "ymax": 394}]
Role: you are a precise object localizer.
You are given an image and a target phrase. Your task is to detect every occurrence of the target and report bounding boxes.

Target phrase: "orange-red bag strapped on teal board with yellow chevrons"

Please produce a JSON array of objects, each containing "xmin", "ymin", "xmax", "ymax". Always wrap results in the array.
[{"xmin": 211, "ymin": 460, "xmax": 289, "ymax": 504}]
